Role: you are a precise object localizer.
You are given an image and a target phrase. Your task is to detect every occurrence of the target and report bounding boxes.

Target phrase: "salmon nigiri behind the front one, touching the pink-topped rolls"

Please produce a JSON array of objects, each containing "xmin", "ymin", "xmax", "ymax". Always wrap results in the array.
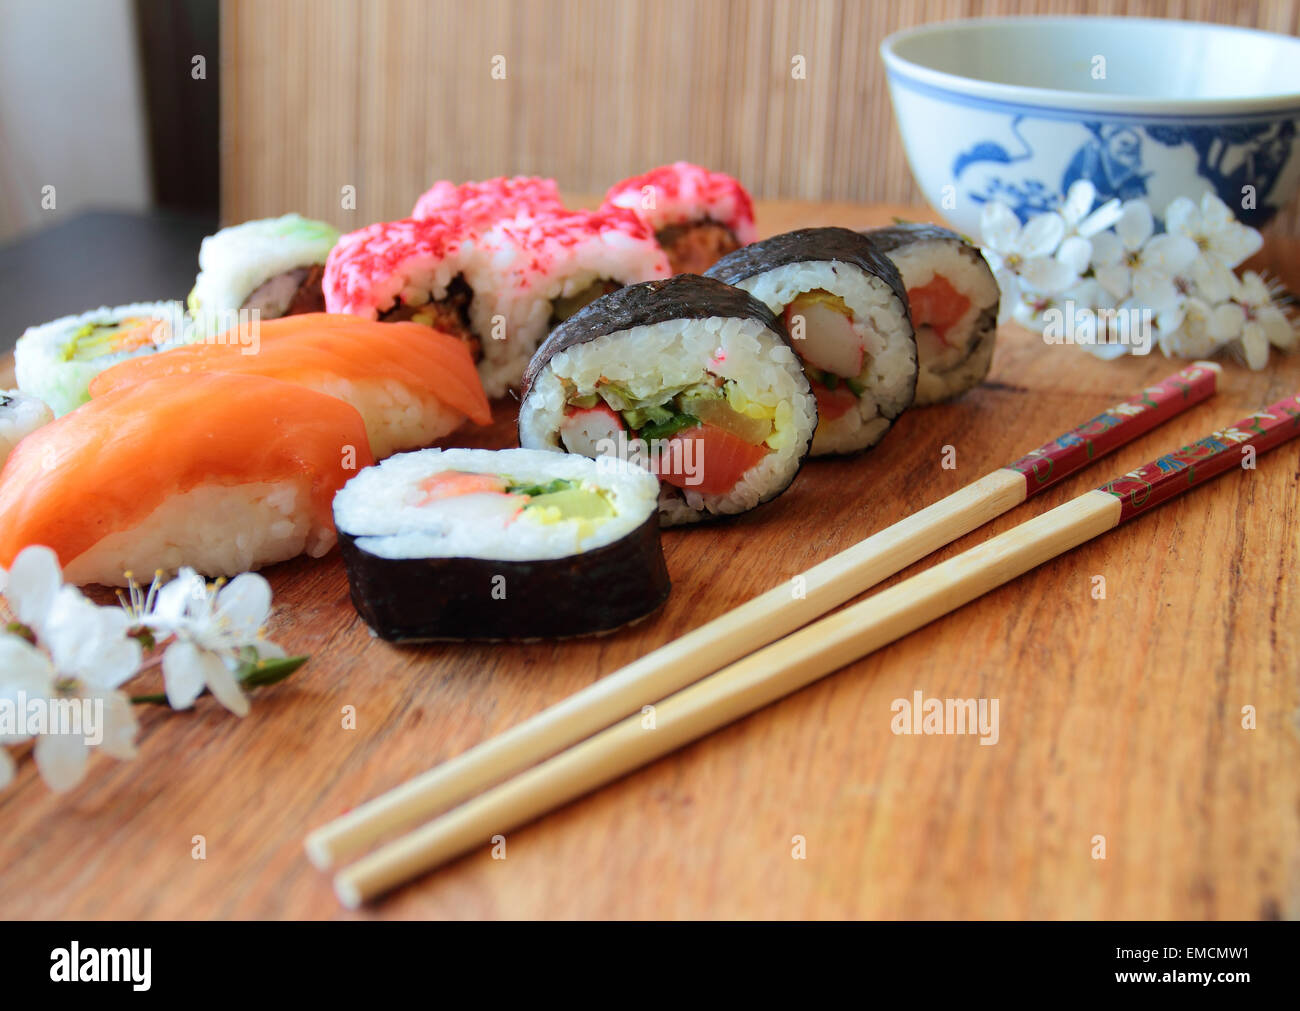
[{"xmin": 90, "ymin": 312, "xmax": 491, "ymax": 459}]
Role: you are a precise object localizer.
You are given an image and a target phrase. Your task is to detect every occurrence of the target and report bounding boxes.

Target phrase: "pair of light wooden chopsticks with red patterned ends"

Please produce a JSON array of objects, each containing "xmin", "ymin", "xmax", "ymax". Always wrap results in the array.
[{"xmin": 307, "ymin": 363, "xmax": 1300, "ymax": 907}]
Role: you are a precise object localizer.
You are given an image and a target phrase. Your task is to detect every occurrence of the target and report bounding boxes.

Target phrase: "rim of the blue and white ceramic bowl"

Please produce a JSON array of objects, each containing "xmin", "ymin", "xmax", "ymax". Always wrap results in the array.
[{"xmin": 880, "ymin": 14, "xmax": 1300, "ymax": 118}]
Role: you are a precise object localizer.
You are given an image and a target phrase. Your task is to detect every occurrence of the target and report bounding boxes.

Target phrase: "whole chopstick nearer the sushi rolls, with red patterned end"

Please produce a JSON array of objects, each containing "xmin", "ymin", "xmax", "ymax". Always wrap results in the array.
[{"xmin": 306, "ymin": 361, "xmax": 1219, "ymax": 871}]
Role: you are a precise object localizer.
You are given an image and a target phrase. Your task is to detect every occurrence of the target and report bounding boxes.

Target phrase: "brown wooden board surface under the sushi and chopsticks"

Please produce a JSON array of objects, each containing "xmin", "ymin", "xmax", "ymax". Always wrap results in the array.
[{"xmin": 0, "ymin": 203, "xmax": 1300, "ymax": 919}]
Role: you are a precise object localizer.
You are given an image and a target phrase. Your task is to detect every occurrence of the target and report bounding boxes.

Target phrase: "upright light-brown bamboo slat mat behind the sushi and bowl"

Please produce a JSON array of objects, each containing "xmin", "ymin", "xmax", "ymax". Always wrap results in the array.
[{"xmin": 221, "ymin": 0, "xmax": 1300, "ymax": 233}]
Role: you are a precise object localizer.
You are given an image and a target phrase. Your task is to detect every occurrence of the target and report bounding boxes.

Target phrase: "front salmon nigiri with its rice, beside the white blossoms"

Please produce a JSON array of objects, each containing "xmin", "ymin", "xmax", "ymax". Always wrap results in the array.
[{"xmin": 0, "ymin": 373, "xmax": 373, "ymax": 586}]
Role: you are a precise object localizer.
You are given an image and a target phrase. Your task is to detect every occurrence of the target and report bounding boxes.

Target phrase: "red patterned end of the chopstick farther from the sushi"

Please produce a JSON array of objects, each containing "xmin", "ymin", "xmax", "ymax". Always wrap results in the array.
[{"xmin": 1100, "ymin": 394, "xmax": 1300, "ymax": 522}]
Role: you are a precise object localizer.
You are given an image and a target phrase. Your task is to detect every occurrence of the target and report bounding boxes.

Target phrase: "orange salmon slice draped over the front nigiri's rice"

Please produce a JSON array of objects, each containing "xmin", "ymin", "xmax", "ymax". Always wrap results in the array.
[{"xmin": 0, "ymin": 373, "xmax": 373, "ymax": 570}]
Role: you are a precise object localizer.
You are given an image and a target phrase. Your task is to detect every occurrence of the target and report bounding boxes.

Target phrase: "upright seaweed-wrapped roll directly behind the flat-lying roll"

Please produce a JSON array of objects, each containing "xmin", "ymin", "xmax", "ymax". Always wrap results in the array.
[{"xmin": 519, "ymin": 274, "xmax": 816, "ymax": 525}]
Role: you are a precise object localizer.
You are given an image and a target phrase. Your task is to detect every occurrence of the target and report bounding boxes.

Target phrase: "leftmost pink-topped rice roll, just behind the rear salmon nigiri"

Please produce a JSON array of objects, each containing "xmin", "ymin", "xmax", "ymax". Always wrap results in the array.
[{"xmin": 324, "ymin": 212, "xmax": 493, "ymax": 361}]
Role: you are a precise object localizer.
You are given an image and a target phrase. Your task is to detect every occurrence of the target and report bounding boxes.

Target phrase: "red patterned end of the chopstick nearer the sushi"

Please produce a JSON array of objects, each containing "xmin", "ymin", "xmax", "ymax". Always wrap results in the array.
[{"xmin": 1006, "ymin": 361, "xmax": 1219, "ymax": 498}]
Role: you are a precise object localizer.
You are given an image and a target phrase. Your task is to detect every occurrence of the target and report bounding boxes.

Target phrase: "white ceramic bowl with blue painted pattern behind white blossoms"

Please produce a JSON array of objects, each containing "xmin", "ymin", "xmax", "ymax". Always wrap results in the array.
[{"xmin": 880, "ymin": 17, "xmax": 1300, "ymax": 235}]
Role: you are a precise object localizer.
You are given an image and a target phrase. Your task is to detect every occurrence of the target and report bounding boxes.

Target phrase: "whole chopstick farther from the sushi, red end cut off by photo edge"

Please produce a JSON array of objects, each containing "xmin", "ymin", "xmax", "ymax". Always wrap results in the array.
[{"xmin": 334, "ymin": 394, "xmax": 1300, "ymax": 907}]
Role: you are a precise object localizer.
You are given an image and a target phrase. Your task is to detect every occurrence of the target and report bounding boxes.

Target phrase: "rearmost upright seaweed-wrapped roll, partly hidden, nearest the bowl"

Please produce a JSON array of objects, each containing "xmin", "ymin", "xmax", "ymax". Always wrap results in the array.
[{"xmin": 863, "ymin": 225, "xmax": 1001, "ymax": 404}]
